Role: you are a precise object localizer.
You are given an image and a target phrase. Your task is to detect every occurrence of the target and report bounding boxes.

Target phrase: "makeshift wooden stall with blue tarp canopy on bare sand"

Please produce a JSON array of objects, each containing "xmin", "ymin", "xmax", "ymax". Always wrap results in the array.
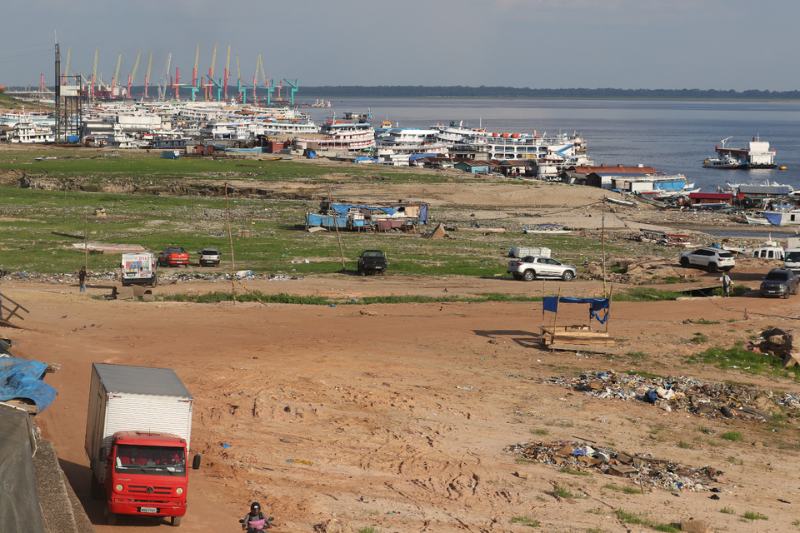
[{"xmin": 540, "ymin": 295, "xmax": 615, "ymax": 352}]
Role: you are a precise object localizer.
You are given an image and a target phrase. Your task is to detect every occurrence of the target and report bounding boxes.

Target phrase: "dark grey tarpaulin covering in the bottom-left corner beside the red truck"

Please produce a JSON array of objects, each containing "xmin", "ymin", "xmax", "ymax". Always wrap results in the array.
[{"xmin": 0, "ymin": 405, "xmax": 44, "ymax": 532}]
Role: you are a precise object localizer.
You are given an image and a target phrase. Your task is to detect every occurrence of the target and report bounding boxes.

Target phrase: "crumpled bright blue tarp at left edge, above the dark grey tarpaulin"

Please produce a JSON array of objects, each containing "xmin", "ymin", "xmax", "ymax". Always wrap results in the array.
[{"xmin": 0, "ymin": 357, "xmax": 56, "ymax": 413}]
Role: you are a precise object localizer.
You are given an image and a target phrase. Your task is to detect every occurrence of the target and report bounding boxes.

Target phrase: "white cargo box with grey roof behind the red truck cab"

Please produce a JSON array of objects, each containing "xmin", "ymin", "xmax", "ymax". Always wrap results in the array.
[{"xmin": 86, "ymin": 363, "xmax": 192, "ymax": 480}]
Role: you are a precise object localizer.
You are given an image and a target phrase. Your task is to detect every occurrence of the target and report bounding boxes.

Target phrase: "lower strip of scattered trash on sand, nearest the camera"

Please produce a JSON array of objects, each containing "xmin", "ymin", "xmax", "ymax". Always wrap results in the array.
[{"xmin": 506, "ymin": 441, "xmax": 722, "ymax": 492}]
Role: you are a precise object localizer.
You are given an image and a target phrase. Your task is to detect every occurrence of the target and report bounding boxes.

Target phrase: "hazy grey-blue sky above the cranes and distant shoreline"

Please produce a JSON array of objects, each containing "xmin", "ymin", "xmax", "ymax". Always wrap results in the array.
[{"xmin": 0, "ymin": 0, "xmax": 800, "ymax": 90}]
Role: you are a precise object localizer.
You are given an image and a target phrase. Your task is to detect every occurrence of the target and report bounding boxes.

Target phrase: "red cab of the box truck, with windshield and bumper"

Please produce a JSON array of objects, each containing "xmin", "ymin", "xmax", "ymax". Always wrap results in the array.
[{"xmin": 102, "ymin": 431, "xmax": 189, "ymax": 526}]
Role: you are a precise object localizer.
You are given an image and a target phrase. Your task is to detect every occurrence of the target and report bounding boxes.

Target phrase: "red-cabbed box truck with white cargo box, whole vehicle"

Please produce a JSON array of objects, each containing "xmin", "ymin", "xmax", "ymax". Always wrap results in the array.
[{"xmin": 86, "ymin": 363, "xmax": 200, "ymax": 526}]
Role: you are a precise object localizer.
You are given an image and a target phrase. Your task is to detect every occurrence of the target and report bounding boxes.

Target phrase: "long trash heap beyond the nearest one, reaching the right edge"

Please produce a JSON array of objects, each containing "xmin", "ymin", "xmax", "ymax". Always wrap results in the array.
[{"xmin": 546, "ymin": 371, "xmax": 800, "ymax": 422}]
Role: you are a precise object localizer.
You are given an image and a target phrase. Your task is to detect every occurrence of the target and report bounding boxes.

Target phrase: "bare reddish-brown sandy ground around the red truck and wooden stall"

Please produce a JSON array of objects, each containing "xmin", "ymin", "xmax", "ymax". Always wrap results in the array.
[{"xmin": 2, "ymin": 282, "xmax": 800, "ymax": 532}]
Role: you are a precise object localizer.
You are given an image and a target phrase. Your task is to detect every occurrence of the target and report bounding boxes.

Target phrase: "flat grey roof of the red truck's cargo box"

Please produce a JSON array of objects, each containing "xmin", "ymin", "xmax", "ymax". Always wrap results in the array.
[{"xmin": 92, "ymin": 363, "xmax": 192, "ymax": 398}]
